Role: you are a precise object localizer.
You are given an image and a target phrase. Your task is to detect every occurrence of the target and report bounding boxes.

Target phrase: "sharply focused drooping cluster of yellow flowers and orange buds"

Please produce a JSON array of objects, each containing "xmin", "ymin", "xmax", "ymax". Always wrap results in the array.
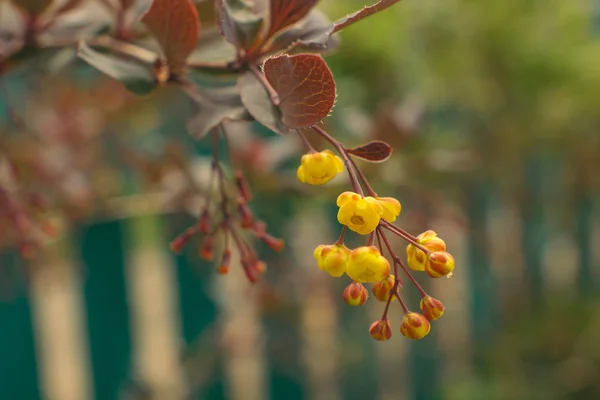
[{"xmin": 297, "ymin": 127, "xmax": 454, "ymax": 340}]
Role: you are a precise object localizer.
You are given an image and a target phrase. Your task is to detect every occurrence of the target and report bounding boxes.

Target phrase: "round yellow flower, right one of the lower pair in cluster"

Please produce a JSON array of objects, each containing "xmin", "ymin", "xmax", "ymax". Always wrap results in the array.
[{"xmin": 346, "ymin": 246, "xmax": 390, "ymax": 283}]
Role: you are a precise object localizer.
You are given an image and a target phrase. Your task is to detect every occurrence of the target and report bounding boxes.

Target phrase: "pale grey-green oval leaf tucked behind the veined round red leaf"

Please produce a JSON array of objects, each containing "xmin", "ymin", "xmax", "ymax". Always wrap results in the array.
[{"xmin": 238, "ymin": 71, "xmax": 289, "ymax": 134}]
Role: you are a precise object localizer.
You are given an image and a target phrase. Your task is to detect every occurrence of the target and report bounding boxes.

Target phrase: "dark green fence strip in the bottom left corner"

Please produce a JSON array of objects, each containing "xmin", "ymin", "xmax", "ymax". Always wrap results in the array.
[{"xmin": 0, "ymin": 253, "xmax": 41, "ymax": 400}]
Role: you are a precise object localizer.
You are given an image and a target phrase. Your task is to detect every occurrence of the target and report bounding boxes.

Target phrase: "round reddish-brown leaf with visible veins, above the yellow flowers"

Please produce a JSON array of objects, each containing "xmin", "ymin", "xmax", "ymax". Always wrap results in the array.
[{"xmin": 263, "ymin": 54, "xmax": 336, "ymax": 128}]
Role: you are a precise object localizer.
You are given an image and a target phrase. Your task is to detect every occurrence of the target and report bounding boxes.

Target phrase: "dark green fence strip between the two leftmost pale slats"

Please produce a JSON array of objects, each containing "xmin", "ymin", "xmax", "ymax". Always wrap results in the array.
[{"xmin": 76, "ymin": 221, "xmax": 131, "ymax": 400}]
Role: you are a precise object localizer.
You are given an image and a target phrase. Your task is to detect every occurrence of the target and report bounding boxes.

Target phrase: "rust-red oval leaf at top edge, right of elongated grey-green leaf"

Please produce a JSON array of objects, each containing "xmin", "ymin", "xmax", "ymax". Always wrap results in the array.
[{"xmin": 142, "ymin": 0, "xmax": 200, "ymax": 74}]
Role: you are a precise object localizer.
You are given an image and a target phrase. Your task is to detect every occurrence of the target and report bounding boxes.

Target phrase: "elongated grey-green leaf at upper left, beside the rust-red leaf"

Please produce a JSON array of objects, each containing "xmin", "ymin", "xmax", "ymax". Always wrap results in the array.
[{"xmin": 77, "ymin": 42, "xmax": 157, "ymax": 94}]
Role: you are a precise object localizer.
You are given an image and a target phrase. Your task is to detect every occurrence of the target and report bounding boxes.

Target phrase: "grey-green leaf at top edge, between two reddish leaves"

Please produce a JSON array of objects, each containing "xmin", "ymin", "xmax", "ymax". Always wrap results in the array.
[{"xmin": 217, "ymin": 0, "xmax": 264, "ymax": 49}]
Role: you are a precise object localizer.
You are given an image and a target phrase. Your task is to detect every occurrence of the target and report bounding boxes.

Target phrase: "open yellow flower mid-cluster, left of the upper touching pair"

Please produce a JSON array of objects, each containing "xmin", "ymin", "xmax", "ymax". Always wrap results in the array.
[{"xmin": 337, "ymin": 192, "xmax": 383, "ymax": 235}]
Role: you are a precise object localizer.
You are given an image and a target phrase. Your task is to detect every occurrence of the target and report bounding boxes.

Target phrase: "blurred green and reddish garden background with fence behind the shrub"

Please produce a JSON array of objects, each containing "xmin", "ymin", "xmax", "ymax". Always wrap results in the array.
[{"xmin": 0, "ymin": 0, "xmax": 600, "ymax": 400}]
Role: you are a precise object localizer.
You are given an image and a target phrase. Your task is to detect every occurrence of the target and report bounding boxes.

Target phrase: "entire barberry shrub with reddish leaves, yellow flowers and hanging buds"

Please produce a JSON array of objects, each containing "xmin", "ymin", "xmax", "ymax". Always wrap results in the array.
[{"xmin": 0, "ymin": 0, "xmax": 454, "ymax": 340}]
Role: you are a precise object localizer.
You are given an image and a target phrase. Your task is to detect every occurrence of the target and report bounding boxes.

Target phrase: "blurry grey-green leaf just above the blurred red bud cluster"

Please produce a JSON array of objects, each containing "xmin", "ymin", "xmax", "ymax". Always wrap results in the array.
[{"xmin": 184, "ymin": 86, "xmax": 250, "ymax": 139}]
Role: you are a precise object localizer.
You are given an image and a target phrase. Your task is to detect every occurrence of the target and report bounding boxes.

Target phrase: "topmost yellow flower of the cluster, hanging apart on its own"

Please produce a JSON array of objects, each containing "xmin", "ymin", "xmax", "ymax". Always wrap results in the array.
[{"xmin": 296, "ymin": 150, "xmax": 344, "ymax": 185}]
